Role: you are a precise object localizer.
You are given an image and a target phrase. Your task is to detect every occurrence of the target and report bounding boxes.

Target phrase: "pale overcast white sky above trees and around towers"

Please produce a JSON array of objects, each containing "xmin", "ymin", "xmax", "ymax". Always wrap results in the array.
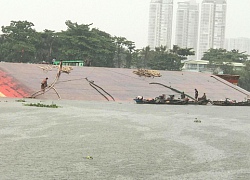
[{"xmin": 0, "ymin": 0, "xmax": 250, "ymax": 48}]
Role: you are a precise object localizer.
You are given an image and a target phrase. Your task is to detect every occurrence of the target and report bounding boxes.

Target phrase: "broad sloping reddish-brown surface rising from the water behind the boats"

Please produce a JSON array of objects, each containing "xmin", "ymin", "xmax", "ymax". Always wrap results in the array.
[{"xmin": 0, "ymin": 63, "xmax": 250, "ymax": 102}]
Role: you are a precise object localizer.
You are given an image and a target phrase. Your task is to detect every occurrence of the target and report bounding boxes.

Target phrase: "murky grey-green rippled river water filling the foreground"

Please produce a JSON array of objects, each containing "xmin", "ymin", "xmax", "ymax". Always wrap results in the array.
[{"xmin": 0, "ymin": 98, "xmax": 250, "ymax": 180}]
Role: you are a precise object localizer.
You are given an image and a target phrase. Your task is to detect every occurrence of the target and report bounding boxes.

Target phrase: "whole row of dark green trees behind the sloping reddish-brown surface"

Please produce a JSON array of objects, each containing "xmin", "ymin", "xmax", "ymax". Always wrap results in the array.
[{"xmin": 0, "ymin": 20, "xmax": 250, "ymax": 90}]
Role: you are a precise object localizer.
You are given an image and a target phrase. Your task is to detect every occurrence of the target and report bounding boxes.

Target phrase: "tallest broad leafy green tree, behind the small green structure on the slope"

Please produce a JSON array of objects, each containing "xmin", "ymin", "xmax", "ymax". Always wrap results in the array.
[{"xmin": 55, "ymin": 21, "xmax": 115, "ymax": 67}]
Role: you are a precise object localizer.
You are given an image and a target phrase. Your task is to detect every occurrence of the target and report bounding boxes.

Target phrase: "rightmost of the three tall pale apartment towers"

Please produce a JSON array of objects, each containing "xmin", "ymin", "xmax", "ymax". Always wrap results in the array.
[{"xmin": 198, "ymin": 0, "xmax": 227, "ymax": 59}]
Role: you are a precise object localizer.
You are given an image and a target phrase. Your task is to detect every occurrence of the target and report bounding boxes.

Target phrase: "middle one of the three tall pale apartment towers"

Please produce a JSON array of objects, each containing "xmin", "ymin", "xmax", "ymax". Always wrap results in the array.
[{"xmin": 175, "ymin": 0, "xmax": 199, "ymax": 58}]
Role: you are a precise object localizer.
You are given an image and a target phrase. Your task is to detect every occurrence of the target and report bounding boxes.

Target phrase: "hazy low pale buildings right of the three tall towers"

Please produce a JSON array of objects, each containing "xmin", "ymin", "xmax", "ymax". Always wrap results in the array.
[{"xmin": 225, "ymin": 37, "xmax": 250, "ymax": 55}]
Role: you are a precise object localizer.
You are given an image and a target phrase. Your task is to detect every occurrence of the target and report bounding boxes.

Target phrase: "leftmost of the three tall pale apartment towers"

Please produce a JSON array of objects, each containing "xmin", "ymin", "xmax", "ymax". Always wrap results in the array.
[{"xmin": 148, "ymin": 0, "xmax": 173, "ymax": 49}]
